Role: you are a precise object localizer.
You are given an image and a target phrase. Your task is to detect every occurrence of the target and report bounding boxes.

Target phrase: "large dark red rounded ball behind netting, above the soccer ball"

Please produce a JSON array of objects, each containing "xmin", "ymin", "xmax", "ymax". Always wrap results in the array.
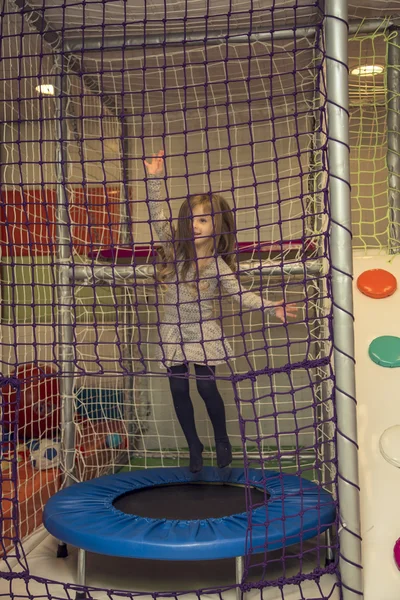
[{"xmin": 3, "ymin": 364, "xmax": 61, "ymax": 441}]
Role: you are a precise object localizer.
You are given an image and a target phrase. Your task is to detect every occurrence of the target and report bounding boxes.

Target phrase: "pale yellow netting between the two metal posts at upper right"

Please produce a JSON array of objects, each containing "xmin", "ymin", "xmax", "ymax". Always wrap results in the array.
[{"xmin": 349, "ymin": 25, "xmax": 393, "ymax": 252}]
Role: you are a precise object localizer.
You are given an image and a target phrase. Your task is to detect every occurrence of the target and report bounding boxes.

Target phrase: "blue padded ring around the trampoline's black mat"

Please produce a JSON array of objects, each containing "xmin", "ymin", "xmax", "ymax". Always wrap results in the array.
[{"xmin": 43, "ymin": 467, "xmax": 336, "ymax": 560}]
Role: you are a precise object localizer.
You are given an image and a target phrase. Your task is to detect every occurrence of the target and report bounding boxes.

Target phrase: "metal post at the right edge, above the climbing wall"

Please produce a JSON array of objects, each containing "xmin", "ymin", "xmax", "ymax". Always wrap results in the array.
[{"xmin": 387, "ymin": 27, "xmax": 400, "ymax": 254}]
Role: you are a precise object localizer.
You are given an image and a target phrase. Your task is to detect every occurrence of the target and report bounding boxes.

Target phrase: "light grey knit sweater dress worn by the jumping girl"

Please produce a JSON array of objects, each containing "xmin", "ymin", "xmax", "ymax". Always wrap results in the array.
[{"xmin": 148, "ymin": 178, "xmax": 272, "ymax": 367}]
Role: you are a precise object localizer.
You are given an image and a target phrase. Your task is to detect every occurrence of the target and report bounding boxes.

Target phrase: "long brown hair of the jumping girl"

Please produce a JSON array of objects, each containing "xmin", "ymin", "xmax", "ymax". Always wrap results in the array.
[{"xmin": 157, "ymin": 194, "xmax": 236, "ymax": 283}]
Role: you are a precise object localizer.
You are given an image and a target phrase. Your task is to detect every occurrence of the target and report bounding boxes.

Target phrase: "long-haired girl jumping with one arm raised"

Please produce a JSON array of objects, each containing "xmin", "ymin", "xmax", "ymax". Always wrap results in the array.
[{"xmin": 145, "ymin": 150, "xmax": 297, "ymax": 473}]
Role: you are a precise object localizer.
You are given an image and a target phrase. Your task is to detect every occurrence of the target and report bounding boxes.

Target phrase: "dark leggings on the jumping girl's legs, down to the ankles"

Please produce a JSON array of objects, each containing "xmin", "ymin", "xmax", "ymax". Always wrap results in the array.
[{"xmin": 168, "ymin": 365, "xmax": 228, "ymax": 448}]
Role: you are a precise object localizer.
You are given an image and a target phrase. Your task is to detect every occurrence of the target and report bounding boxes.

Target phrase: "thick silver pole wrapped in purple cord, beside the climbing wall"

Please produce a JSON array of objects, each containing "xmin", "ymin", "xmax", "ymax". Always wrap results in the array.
[{"xmin": 325, "ymin": 0, "xmax": 363, "ymax": 600}]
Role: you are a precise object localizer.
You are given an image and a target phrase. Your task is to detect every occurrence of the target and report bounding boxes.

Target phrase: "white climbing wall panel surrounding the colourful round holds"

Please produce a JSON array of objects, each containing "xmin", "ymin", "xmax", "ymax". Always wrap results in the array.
[{"xmin": 354, "ymin": 256, "xmax": 400, "ymax": 600}]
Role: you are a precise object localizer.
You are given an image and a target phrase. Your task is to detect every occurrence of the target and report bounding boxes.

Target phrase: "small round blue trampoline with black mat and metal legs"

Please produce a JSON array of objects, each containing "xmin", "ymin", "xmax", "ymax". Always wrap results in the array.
[{"xmin": 43, "ymin": 467, "xmax": 336, "ymax": 598}]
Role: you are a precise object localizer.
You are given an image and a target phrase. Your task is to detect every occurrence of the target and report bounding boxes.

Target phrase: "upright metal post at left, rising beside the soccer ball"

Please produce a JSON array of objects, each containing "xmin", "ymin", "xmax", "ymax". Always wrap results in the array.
[{"xmin": 56, "ymin": 52, "xmax": 75, "ymax": 486}]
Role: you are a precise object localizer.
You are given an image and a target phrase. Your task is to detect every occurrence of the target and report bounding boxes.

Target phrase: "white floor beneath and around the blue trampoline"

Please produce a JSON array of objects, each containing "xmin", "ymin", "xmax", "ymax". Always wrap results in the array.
[{"xmin": 4, "ymin": 536, "xmax": 339, "ymax": 600}]
